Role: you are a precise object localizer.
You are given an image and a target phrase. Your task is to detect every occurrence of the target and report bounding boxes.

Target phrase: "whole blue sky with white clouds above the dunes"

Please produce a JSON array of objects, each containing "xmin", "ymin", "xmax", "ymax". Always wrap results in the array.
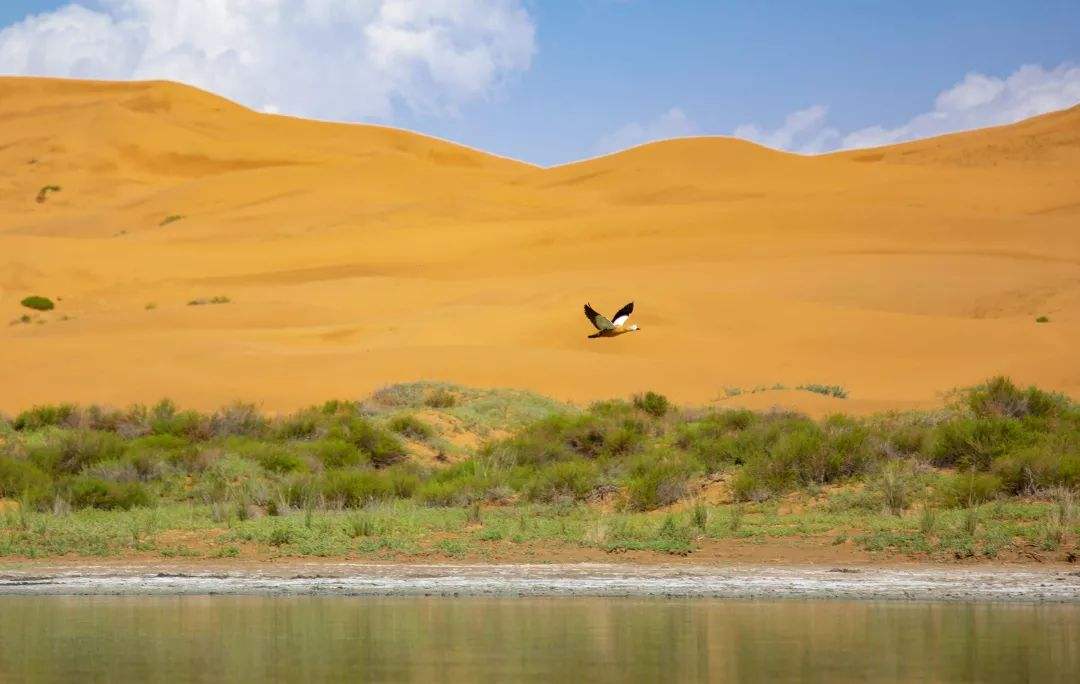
[{"xmin": 0, "ymin": 0, "xmax": 1080, "ymax": 164}]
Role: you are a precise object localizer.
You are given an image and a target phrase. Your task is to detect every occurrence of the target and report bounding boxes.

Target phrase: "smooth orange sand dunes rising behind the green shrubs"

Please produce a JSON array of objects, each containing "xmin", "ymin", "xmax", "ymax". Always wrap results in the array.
[{"xmin": 0, "ymin": 78, "xmax": 1080, "ymax": 413}]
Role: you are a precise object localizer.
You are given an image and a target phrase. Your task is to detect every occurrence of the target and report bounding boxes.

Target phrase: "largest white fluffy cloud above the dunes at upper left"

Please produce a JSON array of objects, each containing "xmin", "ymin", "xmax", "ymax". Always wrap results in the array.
[{"xmin": 0, "ymin": 0, "xmax": 536, "ymax": 120}]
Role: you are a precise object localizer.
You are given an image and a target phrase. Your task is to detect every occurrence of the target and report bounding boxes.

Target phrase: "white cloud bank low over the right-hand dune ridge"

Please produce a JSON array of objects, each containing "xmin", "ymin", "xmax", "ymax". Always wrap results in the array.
[{"xmin": 733, "ymin": 64, "xmax": 1080, "ymax": 153}]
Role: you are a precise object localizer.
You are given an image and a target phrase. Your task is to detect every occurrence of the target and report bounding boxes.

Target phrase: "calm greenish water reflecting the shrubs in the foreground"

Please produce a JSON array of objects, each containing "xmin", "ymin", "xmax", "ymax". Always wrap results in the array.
[{"xmin": 0, "ymin": 596, "xmax": 1080, "ymax": 682}]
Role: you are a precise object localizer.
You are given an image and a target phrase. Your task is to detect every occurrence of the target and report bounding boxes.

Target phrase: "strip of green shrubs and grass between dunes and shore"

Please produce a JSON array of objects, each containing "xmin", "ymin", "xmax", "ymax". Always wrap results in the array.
[{"xmin": 0, "ymin": 378, "xmax": 1080, "ymax": 561}]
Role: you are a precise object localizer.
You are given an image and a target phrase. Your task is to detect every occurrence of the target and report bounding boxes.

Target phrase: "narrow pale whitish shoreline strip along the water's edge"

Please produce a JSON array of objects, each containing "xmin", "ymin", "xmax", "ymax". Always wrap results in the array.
[{"xmin": 0, "ymin": 562, "xmax": 1080, "ymax": 603}]
